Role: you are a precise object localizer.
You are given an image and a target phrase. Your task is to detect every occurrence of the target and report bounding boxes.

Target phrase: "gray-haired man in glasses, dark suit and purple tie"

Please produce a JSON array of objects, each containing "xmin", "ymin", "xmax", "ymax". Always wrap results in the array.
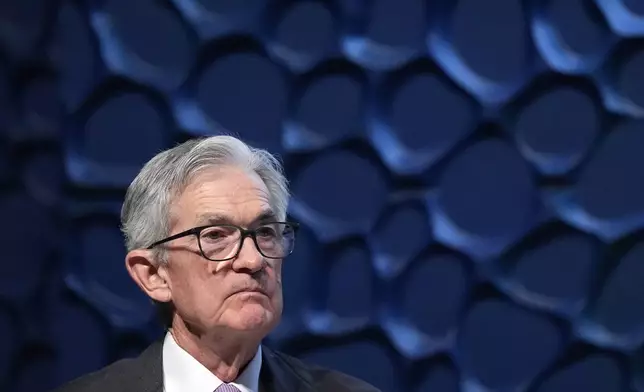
[{"xmin": 58, "ymin": 136, "xmax": 377, "ymax": 392}]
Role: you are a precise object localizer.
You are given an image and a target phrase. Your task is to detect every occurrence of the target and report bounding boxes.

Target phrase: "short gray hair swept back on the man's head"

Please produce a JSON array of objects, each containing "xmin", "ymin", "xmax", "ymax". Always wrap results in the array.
[{"xmin": 121, "ymin": 135, "xmax": 289, "ymax": 261}]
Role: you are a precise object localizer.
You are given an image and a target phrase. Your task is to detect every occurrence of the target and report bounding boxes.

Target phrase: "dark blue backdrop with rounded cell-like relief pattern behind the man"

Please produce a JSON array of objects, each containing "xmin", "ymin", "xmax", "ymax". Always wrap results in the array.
[{"xmin": 0, "ymin": 0, "xmax": 644, "ymax": 392}]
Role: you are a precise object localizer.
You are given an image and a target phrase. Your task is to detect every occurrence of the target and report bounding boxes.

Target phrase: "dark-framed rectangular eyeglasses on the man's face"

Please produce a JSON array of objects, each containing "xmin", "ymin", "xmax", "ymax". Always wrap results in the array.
[{"xmin": 148, "ymin": 222, "xmax": 299, "ymax": 261}]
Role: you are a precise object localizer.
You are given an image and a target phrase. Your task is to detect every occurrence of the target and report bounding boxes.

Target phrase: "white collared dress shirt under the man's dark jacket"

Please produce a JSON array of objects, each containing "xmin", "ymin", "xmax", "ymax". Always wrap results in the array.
[{"xmin": 163, "ymin": 332, "xmax": 262, "ymax": 392}]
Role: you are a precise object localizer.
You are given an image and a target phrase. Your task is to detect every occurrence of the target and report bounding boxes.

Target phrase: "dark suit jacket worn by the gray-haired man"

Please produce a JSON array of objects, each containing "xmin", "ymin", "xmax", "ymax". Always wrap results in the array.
[{"xmin": 54, "ymin": 340, "xmax": 379, "ymax": 392}]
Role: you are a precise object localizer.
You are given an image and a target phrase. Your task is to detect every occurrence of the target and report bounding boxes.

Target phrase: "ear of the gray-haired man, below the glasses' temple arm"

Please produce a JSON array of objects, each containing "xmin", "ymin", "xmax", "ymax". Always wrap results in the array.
[{"xmin": 125, "ymin": 249, "xmax": 172, "ymax": 302}]
